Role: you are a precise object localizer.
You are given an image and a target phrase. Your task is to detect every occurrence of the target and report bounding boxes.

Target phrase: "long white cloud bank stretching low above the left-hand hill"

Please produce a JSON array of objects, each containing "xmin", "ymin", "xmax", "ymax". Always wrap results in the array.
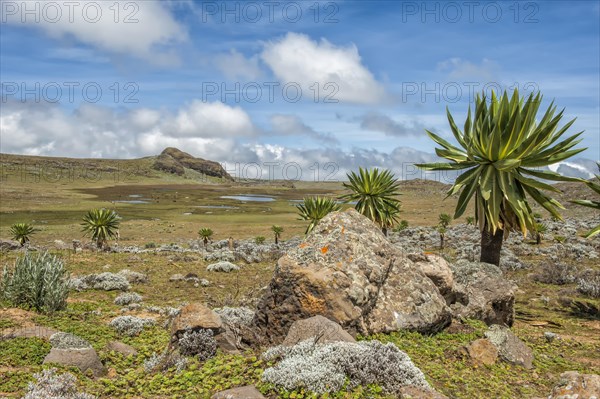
[{"xmin": 0, "ymin": 101, "xmax": 257, "ymax": 159}]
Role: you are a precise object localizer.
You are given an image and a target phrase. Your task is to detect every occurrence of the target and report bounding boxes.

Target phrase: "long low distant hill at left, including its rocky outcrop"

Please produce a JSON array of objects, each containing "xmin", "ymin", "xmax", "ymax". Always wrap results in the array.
[{"xmin": 0, "ymin": 147, "xmax": 233, "ymax": 182}]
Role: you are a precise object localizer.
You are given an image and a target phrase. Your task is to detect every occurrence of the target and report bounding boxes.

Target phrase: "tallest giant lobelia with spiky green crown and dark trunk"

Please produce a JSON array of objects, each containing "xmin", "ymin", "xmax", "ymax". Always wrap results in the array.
[{"xmin": 417, "ymin": 90, "xmax": 585, "ymax": 265}]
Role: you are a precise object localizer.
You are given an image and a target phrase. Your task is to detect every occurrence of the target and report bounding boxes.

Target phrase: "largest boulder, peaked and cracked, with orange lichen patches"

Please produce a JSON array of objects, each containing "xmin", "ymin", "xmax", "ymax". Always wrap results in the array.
[{"xmin": 254, "ymin": 209, "xmax": 451, "ymax": 342}]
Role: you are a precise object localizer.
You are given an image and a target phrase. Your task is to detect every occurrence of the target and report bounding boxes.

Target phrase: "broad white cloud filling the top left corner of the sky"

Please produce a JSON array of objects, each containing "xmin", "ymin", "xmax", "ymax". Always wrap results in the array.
[{"xmin": 2, "ymin": 0, "xmax": 187, "ymax": 65}]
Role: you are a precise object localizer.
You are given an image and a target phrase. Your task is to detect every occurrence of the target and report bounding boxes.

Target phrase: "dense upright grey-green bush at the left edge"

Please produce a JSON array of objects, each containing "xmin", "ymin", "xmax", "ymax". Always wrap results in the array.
[{"xmin": 0, "ymin": 252, "xmax": 69, "ymax": 313}]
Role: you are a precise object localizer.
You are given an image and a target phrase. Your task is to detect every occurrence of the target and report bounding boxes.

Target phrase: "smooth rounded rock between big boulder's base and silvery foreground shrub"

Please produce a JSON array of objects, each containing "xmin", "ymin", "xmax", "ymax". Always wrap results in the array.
[{"xmin": 282, "ymin": 315, "xmax": 356, "ymax": 346}]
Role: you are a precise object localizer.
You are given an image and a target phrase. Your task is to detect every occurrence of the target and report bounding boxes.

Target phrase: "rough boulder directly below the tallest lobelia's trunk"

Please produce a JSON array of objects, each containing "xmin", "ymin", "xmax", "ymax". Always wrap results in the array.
[{"xmin": 450, "ymin": 260, "xmax": 517, "ymax": 326}]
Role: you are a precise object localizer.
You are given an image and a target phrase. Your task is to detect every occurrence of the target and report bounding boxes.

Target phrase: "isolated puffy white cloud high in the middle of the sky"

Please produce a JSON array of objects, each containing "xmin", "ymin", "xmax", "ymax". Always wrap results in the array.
[{"xmin": 261, "ymin": 32, "xmax": 385, "ymax": 104}]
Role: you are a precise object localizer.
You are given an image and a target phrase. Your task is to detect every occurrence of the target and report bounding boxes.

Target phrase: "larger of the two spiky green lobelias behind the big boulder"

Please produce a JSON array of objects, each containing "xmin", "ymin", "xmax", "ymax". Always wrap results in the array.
[{"xmin": 340, "ymin": 168, "xmax": 400, "ymax": 235}]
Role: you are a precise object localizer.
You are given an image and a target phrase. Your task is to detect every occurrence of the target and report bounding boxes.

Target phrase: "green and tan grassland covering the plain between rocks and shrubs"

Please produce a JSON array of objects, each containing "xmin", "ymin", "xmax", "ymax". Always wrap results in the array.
[{"xmin": 0, "ymin": 155, "xmax": 600, "ymax": 399}]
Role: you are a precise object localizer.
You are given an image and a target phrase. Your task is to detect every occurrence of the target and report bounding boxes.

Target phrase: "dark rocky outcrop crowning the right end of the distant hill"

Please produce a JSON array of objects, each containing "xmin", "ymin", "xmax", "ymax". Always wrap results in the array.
[{"xmin": 152, "ymin": 147, "xmax": 233, "ymax": 180}]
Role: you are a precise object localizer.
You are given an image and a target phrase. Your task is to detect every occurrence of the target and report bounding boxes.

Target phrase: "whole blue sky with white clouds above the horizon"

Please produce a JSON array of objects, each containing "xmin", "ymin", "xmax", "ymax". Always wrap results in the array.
[{"xmin": 0, "ymin": 0, "xmax": 600, "ymax": 180}]
